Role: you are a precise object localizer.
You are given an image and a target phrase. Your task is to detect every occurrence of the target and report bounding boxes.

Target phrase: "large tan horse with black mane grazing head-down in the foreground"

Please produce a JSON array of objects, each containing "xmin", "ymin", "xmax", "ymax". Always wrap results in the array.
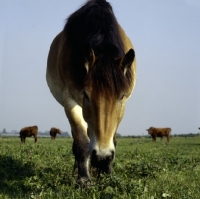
[{"xmin": 46, "ymin": 0, "xmax": 136, "ymax": 184}]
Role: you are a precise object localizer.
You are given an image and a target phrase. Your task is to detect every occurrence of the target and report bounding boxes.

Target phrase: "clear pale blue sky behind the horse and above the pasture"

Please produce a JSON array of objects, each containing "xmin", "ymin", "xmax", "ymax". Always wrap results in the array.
[{"xmin": 0, "ymin": 0, "xmax": 200, "ymax": 135}]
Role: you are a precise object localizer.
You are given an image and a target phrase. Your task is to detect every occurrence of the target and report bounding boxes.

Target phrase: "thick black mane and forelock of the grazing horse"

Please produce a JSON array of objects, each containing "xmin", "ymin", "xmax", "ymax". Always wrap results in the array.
[{"xmin": 63, "ymin": 0, "xmax": 132, "ymax": 96}]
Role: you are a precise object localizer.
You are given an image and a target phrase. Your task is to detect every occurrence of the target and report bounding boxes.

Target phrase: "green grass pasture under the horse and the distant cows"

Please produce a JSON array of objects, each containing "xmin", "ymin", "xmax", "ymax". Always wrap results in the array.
[{"xmin": 0, "ymin": 136, "xmax": 200, "ymax": 199}]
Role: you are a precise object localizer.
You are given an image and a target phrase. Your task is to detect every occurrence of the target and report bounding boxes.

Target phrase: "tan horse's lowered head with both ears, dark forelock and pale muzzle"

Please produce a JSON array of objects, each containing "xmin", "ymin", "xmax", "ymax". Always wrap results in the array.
[{"xmin": 82, "ymin": 49, "xmax": 135, "ymax": 173}]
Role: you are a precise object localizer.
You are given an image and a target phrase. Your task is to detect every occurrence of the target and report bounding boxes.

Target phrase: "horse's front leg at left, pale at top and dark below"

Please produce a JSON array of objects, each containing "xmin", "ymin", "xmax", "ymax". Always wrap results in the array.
[{"xmin": 65, "ymin": 105, "xmax": 90, "ymax": 186}]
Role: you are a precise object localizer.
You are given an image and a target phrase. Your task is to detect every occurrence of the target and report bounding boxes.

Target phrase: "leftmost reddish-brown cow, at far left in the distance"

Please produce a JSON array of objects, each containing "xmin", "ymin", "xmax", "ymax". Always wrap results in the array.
[{"xmin": 19, "ymin": 126, "xmax": 38, "ymax": 143}]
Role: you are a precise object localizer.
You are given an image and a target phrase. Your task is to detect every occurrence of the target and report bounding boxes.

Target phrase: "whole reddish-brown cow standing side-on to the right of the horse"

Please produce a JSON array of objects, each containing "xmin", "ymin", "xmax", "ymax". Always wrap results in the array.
[{"xmin": 147, "ymin": 127, "xmax": 171, "ymax": 142}]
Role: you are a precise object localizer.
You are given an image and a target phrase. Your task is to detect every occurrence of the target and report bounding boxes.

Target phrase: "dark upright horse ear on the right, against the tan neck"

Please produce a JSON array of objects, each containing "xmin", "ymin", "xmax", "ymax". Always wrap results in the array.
[{"xmin": 120, "ymin": 48, "xmax": 135, "ymax": 75}]
